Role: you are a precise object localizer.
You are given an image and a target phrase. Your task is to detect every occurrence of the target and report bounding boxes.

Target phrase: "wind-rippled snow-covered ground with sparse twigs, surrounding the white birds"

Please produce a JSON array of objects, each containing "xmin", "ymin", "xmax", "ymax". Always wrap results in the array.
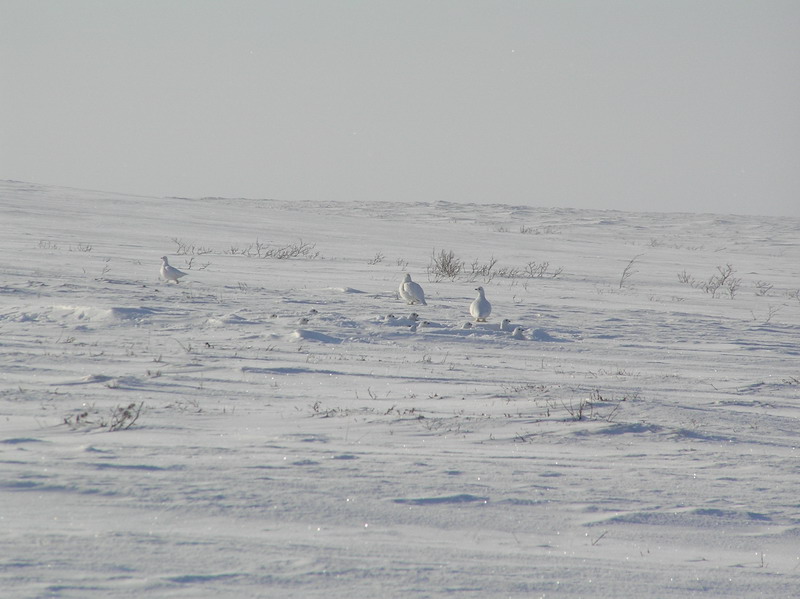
[{"xmin": 0, "ymin": 181, "xmax": 800, "ymax": 598}]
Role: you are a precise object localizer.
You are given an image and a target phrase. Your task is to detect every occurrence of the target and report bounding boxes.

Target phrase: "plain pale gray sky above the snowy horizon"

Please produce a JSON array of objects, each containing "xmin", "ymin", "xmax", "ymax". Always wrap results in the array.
[{"xmin": 0, "ymin": 0, "xmax": 800, "ymax": 216}]
